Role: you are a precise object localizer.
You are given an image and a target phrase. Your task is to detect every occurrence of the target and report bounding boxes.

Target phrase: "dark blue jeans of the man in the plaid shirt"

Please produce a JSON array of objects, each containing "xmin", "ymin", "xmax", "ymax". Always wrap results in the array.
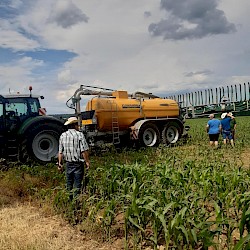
[{"xmin": 66, "ymin": 162, "xmax": 84, "ymax": 199}]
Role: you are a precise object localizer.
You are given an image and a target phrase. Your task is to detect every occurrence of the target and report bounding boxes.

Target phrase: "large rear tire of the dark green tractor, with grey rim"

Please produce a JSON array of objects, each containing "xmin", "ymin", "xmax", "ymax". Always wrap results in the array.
[{"xmin": 19, "ymin": 123, "xmax": 63, "ymax": 162}]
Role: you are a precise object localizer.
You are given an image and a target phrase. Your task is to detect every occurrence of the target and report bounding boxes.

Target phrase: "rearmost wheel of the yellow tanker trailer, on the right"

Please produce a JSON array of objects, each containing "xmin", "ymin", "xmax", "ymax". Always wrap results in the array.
[{"xmin": 162, "ymin": 122, "xmax": 182, "ymax": 145}]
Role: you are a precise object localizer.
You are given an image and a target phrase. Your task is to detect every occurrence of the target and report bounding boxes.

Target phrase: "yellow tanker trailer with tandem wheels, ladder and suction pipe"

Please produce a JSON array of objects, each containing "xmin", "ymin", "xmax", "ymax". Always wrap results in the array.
[{"xmin": 71, "ymin": 85, "xmax": 186, "ymax": 147}]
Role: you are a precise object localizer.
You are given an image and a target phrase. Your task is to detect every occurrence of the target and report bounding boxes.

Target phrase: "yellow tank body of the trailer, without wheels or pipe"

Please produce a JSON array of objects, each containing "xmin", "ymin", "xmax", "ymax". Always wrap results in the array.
[{"xmin": 83, "ymin": 91, "xmax": 179, "ymax": 132}]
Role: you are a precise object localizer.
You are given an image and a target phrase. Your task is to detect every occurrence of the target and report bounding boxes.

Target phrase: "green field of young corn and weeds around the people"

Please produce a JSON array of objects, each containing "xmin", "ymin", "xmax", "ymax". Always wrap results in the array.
[{"xmin": 0, "ymin": 117, "xmax": 250, "ymax": 249}]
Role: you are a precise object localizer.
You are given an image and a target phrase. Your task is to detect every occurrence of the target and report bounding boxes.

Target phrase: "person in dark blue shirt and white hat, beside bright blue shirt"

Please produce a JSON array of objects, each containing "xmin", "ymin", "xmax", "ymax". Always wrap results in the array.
[{"xmin": 221, "ymin": 113, "xmax": 234, "ymax": 147}]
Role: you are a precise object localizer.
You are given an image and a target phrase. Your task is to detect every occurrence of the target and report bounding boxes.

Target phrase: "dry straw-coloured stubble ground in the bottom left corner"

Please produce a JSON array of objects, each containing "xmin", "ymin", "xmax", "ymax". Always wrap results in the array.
[{"xmin": 0, "ymin": 204, "xmax": 124, "ymax": 250}]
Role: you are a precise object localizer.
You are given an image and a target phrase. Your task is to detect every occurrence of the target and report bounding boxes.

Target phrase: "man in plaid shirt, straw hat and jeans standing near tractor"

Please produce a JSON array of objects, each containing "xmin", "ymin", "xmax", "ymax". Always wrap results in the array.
[{"xmin": 58, "ymin": 117, "xmax": 90, "ymax": 199}]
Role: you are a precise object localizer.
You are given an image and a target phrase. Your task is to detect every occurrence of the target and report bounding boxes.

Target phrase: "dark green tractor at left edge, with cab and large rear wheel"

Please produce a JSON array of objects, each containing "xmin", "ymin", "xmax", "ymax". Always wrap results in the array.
[{"xmin": 0, "ymin": 94, "xmax": 63, "ymax": 162}]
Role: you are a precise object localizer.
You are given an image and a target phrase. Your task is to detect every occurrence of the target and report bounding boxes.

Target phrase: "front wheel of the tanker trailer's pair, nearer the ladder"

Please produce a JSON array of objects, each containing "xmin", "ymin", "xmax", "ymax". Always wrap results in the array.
[{"xmin": 139, "ymin": 123, "xmax": 160, "ymax": 147}]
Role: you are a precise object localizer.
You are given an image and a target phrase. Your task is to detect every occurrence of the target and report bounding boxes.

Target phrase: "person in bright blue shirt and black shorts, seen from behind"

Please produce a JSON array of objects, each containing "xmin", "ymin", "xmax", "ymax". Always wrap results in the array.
[{"xmin": 206, "ymin": 114, "xmax": 221, "ymax": 148}]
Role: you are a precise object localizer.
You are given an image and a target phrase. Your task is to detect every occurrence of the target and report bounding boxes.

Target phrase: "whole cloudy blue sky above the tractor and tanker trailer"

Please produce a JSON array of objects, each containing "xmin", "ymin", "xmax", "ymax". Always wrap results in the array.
[{"xmin": 0, "ymin": 0, "xmax": 250, "ymax": 113}]
